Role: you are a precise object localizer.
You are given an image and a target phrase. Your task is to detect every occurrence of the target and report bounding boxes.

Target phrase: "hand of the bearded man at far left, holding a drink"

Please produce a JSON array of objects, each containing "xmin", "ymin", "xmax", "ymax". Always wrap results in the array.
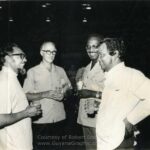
[{"xmin": 25, "ymin": 105, "xmax": 42, "ymax": 117}]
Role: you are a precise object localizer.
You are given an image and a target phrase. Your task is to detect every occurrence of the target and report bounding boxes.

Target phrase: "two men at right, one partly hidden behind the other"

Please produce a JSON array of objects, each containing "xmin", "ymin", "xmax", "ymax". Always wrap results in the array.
[{"xmin": 76, "ymin": 35, "xmax": 150, "ymax": 150}]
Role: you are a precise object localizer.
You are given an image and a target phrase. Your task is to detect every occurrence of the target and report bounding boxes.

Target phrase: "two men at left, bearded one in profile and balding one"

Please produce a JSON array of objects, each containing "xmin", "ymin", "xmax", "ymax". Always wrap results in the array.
[{"xmin": 0, "ymin": 41, "xmax": 72, "ymax": 150}]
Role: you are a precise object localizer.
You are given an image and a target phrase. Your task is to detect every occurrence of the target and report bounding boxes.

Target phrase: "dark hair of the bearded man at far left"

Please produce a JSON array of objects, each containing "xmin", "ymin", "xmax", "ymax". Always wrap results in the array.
[{"xmin": 0, "ymin": 43, "xmax": 18, "ymax": 70}]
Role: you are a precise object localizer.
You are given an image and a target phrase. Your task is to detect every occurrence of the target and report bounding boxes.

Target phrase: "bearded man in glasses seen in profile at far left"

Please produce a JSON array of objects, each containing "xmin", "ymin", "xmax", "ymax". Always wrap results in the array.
[{"xmin": 0, "ymin": 44, "xmax": 41, "ymax": 150}]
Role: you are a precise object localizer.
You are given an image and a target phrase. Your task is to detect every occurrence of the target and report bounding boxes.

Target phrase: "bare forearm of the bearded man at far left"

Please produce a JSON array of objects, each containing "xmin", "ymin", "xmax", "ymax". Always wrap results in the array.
[{"xmin": 0, "ymin": 110, "xmax": 28, "ymax": 128}]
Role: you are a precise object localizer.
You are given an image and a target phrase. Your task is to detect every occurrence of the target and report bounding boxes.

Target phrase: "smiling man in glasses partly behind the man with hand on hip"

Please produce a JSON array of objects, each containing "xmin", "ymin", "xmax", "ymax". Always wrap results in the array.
[{"xmin": 76, "ymin": 34, "xmax": 104, "ymax": 150}]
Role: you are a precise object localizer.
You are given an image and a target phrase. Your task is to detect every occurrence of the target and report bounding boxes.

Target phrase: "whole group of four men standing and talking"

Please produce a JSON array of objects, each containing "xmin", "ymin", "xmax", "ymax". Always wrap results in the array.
[{"xmin": 0, "ymin": 34, "xmax": 150, "ymax": 150}]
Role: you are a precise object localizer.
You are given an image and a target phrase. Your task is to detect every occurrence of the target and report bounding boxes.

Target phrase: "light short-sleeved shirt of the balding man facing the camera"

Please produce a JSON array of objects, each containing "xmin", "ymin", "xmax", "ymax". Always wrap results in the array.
[{"xmin": 23, "ymin": 63, "xmax": 71, "ymax": 124}]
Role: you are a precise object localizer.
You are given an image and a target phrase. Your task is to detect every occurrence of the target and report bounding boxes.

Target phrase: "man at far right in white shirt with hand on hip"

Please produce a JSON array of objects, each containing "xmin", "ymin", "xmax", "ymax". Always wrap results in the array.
[{"xmin": 96, "ymin": 38, "xmax": 150, "ymax": 150}]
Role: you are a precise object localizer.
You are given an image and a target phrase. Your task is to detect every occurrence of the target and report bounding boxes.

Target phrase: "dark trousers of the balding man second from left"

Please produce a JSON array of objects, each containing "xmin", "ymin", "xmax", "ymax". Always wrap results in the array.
[{"xmin": 32, "ymin": 121, "xmax": 66, "ymax": 150}]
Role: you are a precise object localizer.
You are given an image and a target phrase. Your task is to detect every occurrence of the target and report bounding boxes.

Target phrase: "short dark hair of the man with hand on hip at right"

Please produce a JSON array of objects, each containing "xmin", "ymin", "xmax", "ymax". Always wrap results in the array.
[{"xmin": 102, "ymin": 38, "xmax": 125, "ymax": 60}]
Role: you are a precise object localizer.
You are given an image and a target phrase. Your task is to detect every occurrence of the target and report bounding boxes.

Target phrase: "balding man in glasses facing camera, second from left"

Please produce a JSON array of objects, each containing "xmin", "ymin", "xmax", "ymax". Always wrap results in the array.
[{"xmin": 24, "ymin": 41, "xmax": 71, "ymax": 149}]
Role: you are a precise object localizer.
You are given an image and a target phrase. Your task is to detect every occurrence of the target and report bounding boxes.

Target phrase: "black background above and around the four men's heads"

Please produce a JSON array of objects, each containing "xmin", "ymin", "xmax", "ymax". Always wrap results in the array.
[{"xmin": 0, "ymin": 0, "xmax": 150, "ymax": 148}]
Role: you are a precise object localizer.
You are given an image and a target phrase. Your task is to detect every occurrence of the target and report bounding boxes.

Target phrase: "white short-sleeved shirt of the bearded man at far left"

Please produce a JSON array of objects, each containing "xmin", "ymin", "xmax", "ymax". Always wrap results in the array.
[{"xmin": 0, "ymin": 67, "xmax": 32, "ymax": 150}]
